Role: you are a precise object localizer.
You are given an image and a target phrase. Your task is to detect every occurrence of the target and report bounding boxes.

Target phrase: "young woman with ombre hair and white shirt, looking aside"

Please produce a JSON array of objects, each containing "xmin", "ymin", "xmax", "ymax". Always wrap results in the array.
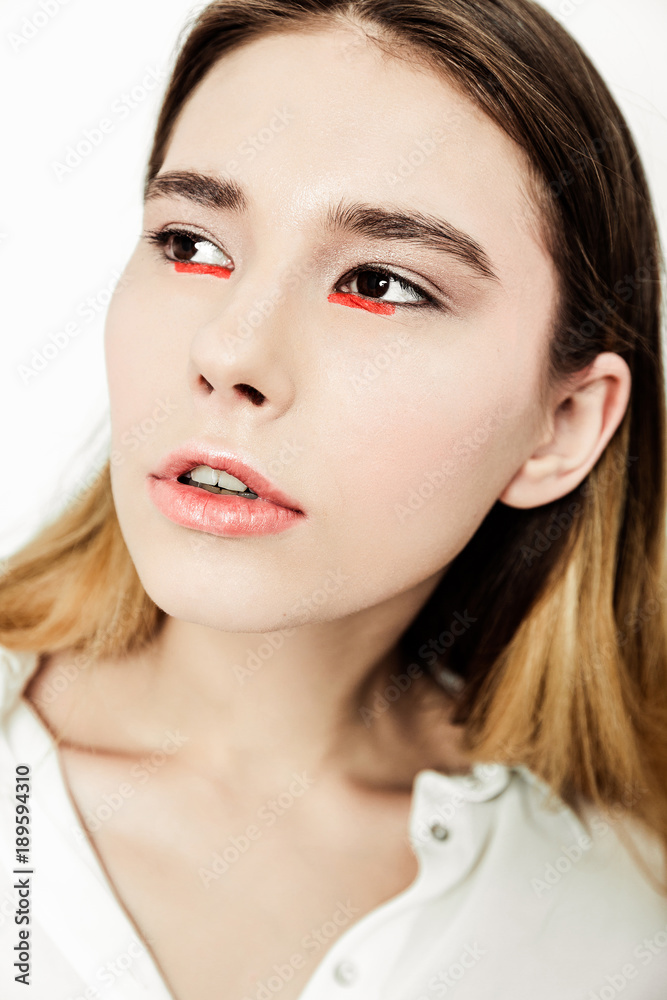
[{"xmin": 0, "ymin": 0, "xmax": 667, "ymax": 1000}]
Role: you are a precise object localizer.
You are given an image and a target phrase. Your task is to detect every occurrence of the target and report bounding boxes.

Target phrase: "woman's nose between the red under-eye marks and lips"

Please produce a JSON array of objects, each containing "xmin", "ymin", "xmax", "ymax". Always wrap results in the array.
[{"xmin": 189, "ymin": 266, "xmax": 299, "ymax": 419}]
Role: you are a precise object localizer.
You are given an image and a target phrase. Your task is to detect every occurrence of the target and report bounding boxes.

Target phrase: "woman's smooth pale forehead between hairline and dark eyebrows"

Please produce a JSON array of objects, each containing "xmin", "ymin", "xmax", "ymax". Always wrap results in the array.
[{"xmin": 162, "ymin": 28, "xmax": 550, "ymax": 280}]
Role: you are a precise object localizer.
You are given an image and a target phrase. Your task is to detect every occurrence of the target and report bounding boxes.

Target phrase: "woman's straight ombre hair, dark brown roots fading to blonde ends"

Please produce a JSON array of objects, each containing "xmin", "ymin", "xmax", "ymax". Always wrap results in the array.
[{"xmin": 0, "ymin": 0, "xmax": 667, "ymax": 892}]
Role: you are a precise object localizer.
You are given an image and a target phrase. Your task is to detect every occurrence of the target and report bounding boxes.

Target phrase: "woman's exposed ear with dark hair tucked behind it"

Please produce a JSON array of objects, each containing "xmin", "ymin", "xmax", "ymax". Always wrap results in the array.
[{"xmin": 498, "ymin": 351, "xmax": 632, "ymax": 508}]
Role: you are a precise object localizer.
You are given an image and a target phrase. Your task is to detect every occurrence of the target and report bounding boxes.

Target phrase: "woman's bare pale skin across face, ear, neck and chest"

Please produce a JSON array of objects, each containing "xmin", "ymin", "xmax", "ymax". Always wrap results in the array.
[{"xmin": 27, "ymin": 15, "xmax": 630, "ymax": 1000}]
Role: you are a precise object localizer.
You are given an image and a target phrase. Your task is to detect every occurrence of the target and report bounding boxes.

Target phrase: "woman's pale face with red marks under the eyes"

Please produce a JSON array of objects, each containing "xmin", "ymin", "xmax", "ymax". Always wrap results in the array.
[{"xmin": 106, "ymin": 30, "xmax": 556, "ymax": 632}]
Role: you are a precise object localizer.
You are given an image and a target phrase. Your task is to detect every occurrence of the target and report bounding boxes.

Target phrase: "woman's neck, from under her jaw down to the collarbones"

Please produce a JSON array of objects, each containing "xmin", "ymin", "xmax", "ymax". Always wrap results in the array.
[{"xmin": 128, "ymin": 580, "xmax": 466, "ymax": 786}]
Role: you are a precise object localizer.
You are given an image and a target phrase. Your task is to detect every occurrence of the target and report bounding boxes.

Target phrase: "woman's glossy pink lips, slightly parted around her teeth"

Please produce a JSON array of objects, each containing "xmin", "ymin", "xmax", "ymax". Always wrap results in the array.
[{"xmin": 147, "ymin": 445, "xmax": 305, "ymax": 535}]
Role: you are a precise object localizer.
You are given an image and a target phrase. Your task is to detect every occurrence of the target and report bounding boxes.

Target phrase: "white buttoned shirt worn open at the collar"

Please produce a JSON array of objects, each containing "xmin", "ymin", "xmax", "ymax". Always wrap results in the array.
[{"xmin": 0, "ymin": 647, "xmax": 667, "ymax": 1000}]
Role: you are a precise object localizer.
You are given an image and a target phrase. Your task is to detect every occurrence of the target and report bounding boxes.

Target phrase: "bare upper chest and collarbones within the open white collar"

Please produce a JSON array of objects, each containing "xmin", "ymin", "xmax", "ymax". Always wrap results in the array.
[{"xmin": 25, "ymin": 636, "xmax": 469, "ymax": 1000}]
